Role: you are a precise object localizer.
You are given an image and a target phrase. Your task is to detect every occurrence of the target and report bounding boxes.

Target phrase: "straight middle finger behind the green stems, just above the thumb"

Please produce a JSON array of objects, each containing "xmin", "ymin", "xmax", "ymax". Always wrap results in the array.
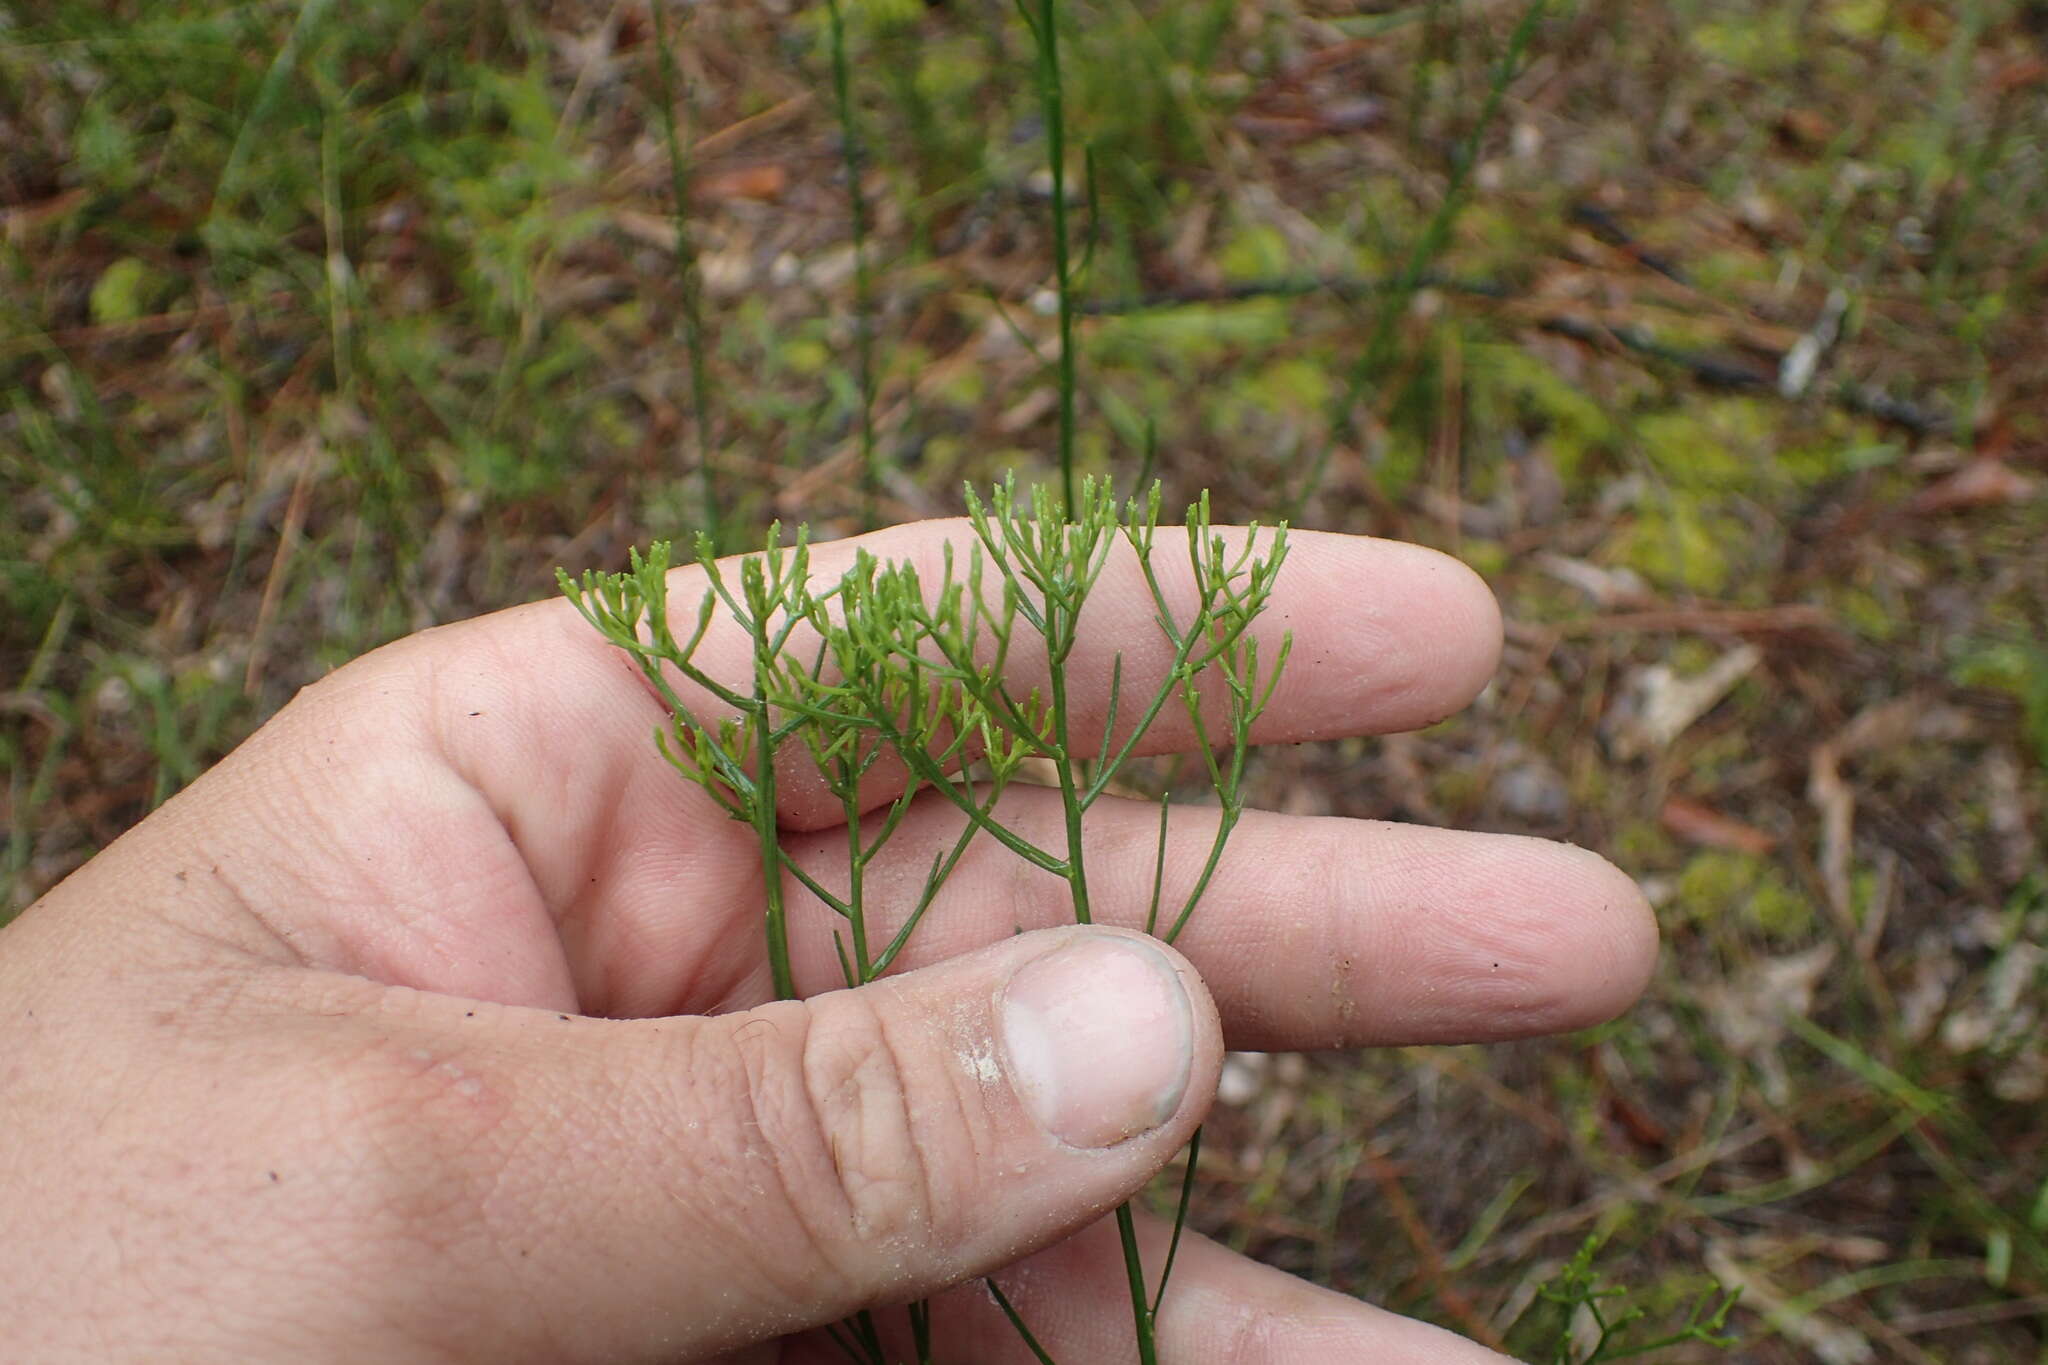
[{"xmin": 784, "ymin": 788, "xmax": 1657, "ymax": 1050}]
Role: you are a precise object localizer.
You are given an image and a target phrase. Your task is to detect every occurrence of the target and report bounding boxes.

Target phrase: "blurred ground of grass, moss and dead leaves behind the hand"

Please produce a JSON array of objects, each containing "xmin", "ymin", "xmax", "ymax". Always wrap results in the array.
[{"xmin": 0, "ymin": 0, "xmax": 2048, "ymax": 1365}]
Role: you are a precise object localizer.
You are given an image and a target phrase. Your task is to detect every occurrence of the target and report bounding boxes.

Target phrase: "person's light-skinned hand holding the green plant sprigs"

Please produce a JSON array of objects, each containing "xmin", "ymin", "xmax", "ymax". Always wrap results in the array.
[{"xmin": 0, "ymin": 522, "xmax": 1653, "ymax": 1365}]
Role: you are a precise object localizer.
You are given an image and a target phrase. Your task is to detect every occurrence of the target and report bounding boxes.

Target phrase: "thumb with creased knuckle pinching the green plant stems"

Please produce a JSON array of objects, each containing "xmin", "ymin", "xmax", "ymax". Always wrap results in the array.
[{"xmin": 473, "ymin": 927, "xmax": 1223, "ymax": 1359}]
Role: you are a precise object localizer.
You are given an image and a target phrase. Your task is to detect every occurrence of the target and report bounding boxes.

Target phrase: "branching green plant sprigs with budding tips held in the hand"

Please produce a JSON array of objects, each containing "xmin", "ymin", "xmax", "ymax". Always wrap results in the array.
[{"xmin": 559, "ymin": 479, "xmax": 1288, "ymax": 1365}]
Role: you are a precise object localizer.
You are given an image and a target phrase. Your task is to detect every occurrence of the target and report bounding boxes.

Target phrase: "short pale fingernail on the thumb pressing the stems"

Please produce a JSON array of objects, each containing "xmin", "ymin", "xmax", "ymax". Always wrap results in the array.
[{"xmin": 1001, "ymin": 935, "xmax": 1194, "ymax": 1148}]
